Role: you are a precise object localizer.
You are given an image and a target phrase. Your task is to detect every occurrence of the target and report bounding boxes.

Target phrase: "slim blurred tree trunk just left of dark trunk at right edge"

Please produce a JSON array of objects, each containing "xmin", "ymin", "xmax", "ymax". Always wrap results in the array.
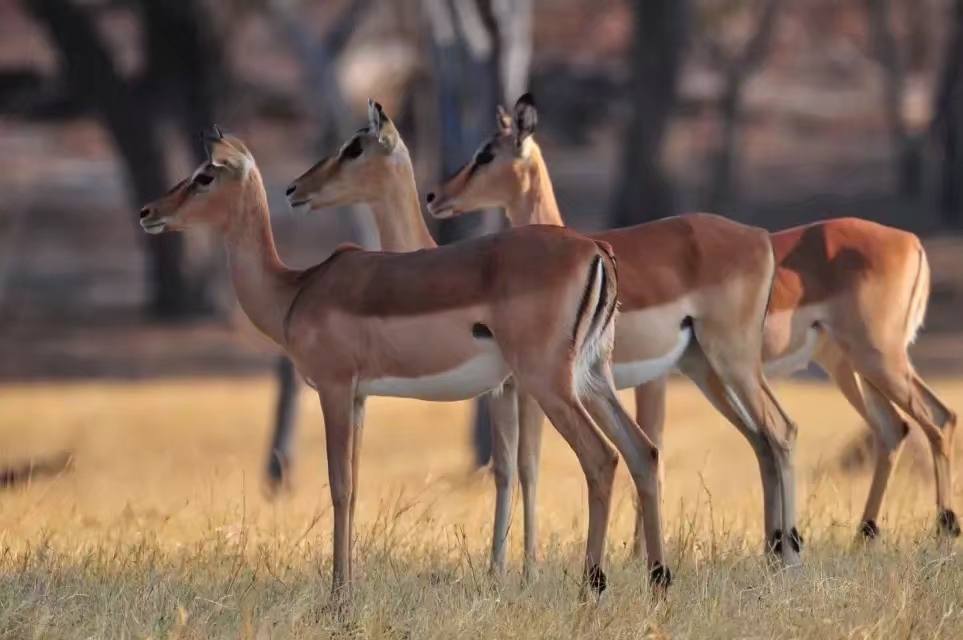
[{"xmin": 866, "ymin": 0, "xmax": 924, "ymax": 200}]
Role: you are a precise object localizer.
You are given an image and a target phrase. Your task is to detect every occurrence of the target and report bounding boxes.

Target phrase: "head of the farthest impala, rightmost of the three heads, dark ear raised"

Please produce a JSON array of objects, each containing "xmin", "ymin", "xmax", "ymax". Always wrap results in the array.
[{"xmin": 427, "ymin": 93, "xmax": 538, "ymax": 218}]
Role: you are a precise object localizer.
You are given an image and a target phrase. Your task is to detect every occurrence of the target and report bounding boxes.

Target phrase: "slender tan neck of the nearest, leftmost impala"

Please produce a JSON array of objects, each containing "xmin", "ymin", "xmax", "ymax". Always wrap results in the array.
[{"xmin": 225, "ymin": 169, "xmax": 295, "ymax": 346}]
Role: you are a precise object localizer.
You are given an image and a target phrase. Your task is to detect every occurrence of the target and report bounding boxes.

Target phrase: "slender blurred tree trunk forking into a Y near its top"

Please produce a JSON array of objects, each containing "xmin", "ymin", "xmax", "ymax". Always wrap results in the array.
[{"xmin": 700, "ymin": 0, "xmax": 781, "ymax": 215}]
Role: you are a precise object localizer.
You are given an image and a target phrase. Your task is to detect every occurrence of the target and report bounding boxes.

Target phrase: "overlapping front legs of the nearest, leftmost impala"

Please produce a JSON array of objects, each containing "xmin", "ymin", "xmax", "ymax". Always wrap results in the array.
[{"xmin": 318, "ymin": 384, "xmax": 355, "ymax": 610}]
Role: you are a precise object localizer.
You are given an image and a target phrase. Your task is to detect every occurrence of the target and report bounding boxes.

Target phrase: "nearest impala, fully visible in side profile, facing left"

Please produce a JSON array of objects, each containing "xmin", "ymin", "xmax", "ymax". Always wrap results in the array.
[{"xmin": 141, "ymin": 125, "xmax": 669, "ymax": 601}]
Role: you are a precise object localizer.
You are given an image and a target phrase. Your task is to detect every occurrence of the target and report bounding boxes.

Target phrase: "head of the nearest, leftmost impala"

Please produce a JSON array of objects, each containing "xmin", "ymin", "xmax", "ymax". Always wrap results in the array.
[{"xmin": 140, "ymin": 126, "xmax": 260, "ymax": 233}]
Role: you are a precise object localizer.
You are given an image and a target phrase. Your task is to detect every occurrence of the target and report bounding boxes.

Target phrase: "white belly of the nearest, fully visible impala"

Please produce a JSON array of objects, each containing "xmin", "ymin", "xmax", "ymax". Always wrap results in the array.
[{"xmin": 359, "ymin": 349, "xmax": 511, "ymax": 402}]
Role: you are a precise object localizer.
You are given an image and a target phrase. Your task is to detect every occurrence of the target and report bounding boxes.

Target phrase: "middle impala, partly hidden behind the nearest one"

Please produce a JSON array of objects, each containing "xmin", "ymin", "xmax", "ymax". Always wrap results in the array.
[{"xmin": 289, "ymin": 105, "xmax": 798, "ymax": 575}]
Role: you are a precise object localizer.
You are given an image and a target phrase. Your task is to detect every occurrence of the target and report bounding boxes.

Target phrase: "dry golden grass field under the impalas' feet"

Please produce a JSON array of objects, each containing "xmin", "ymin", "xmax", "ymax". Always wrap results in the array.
[{"xmin": 0, "ymin": 378, "xmax": 963, "ymax": 639}]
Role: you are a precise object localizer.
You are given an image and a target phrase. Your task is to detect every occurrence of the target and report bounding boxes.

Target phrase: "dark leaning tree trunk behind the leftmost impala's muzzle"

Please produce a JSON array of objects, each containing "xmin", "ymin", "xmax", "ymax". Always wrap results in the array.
[{"xmin": 29, "ymin": 0, "xmax": 221, "ymax": 318}]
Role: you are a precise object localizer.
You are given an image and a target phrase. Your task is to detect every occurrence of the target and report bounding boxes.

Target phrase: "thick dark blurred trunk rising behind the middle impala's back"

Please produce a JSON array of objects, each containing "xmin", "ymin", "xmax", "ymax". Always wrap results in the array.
[{"xmin": 611, "ymin": 0, "xmax": 689, "ymax": 227}]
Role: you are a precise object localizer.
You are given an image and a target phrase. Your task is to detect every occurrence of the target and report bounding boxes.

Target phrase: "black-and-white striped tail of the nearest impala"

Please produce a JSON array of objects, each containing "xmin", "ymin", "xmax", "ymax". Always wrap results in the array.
[{"xmin": 574, "ymin": 242, "xmax": 618, "ymax": 395}]
